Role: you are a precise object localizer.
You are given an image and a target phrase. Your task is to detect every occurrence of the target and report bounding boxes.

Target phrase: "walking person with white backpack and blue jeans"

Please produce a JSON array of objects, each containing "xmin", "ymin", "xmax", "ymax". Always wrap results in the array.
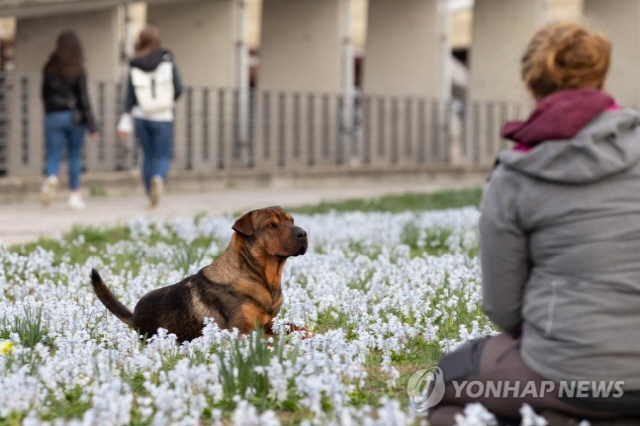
[{"xmin": 118, "ymin": 26, "xmax": 182, "ymax": 207}]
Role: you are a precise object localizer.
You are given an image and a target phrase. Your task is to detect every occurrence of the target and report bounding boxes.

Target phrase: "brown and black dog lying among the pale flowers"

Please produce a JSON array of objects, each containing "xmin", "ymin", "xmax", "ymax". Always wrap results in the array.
[{"xmin": 91, "ymin": 207, "xmax": 308, "ymax": 342}]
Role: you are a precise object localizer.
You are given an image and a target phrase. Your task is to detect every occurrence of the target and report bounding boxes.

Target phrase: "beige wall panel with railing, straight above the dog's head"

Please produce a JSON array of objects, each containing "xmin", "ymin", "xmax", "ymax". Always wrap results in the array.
[{"xmin": 255, "ymin": 0, "xmax": 354, "ymax": 167}]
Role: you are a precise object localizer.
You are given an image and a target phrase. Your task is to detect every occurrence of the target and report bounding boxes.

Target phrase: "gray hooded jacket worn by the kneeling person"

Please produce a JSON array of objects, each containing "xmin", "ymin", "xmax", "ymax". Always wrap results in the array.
[{"xmin": 480, "ymin": 110, "xmax": 640, "ymax": 389}]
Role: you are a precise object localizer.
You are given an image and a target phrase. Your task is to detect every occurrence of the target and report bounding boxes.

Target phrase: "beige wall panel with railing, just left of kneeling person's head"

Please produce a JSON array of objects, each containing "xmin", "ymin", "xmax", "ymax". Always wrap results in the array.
[{"xmin": 463, "ymin": 0, "xmax": 584, "ymax": 166}]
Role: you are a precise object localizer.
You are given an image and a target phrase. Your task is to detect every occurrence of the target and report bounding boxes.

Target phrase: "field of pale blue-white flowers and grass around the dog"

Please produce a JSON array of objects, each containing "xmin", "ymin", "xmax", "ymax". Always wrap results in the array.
[{"xmin": 0, "ymin": 192, "xmax": 516, "ymax": 426}]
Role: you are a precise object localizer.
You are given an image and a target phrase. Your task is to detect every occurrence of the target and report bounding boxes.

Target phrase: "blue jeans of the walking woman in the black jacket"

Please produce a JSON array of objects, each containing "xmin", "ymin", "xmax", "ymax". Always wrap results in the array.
[{"xmin": 44, "ymin": 111, "xmax": 87, "ymax": 191}]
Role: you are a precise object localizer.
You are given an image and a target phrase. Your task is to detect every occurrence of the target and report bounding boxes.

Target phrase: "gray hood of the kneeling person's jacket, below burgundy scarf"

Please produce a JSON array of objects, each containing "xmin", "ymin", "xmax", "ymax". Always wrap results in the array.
[{"xmin": 498, "ymin": 109, "xmax": 640, "ymax": 184}]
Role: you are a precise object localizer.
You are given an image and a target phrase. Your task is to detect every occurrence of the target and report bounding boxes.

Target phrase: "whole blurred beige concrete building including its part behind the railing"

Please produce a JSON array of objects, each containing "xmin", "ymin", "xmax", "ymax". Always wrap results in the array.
[{"xmin": 0, "ymin": 0, "xmax": 640, "ymax": 173}]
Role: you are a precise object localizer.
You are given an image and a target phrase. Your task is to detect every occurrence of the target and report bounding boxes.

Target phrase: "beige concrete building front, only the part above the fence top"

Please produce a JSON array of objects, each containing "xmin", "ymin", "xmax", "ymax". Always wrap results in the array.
[{"xmin": 5, "ymin": 0, "xmax": 640, "ymax": 104}]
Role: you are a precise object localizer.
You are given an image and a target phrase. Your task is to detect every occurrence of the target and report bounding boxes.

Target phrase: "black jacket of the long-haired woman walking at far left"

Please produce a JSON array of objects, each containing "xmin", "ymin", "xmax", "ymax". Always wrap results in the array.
[{"xmin": 42, "ymin": 73, "xmax": 98, "ymax": 133}]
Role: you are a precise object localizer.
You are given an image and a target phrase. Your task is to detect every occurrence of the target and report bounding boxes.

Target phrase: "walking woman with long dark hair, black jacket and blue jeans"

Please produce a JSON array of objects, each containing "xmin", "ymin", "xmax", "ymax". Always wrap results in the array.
[{"xmin": 41, "ymin": 31, "xmax": 98, "ymax": 209}]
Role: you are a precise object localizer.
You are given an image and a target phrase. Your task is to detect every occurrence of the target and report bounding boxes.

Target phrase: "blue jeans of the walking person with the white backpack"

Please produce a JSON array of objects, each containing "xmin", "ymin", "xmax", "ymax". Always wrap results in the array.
[{"xmin": 135, "ymin": 118, "xmax": 173, "ymax": 194}]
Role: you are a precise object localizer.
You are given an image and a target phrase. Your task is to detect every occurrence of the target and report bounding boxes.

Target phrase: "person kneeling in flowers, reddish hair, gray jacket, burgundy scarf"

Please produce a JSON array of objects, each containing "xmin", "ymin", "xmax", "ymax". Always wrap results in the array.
[{"xmin": 429, "ymin": 23, "xmax": 640, "ymax": 426}]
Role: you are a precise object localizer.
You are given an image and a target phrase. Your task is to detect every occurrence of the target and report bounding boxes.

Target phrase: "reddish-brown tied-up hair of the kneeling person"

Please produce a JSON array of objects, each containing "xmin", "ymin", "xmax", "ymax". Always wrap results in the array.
[{"xmin": 521, "ymin": 23, "xmax": 611, "ymax": 100}]
